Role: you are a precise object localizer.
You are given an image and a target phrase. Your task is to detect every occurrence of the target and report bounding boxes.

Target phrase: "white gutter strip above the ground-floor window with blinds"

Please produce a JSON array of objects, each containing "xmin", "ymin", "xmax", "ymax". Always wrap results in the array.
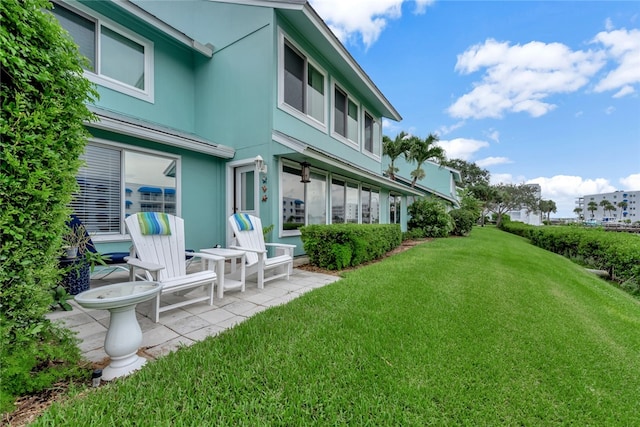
[{"xmin": 85, "ymin": 106, "xmax": 236, "ymax": 159}]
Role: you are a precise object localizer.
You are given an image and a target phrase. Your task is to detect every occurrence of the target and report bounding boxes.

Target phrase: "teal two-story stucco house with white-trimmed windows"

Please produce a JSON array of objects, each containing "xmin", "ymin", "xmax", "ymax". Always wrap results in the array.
[{"xmin": 52, "ymin": 0, "xmax": 459, "ymax": 255}]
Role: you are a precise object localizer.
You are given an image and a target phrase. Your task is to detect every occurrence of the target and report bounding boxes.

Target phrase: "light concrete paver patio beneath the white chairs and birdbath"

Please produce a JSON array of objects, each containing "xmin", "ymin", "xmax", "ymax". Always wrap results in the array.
[{"xmin": 48, "ymin": 266, "xmax": 339, "ymax": 363}]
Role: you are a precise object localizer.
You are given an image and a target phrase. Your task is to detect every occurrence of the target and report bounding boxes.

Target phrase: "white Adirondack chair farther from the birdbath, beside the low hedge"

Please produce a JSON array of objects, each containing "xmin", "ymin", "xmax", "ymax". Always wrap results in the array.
[{"xmin": 229, "ymin": 215, "xmax": 296, "ymax": 289}]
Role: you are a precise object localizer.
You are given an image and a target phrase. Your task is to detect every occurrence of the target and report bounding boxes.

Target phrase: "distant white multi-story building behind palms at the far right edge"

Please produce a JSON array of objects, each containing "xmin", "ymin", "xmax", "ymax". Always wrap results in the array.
[{"xmin": 576, "ymin": 191, "xmax": 640, "ymax": 222}]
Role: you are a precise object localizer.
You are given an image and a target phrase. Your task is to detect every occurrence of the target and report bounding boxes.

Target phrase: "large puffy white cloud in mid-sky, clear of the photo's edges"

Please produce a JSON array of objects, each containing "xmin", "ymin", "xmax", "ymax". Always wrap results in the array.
[{"xmin": 448, "ymin": 39, "xmax": 605, "ymax": 119}]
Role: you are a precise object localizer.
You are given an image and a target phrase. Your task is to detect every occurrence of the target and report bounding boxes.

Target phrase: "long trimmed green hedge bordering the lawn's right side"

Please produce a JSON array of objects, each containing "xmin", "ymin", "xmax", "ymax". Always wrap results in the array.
[{"xmin": 502, "ymin": 222, "xmax": 640, "ymax": 295}]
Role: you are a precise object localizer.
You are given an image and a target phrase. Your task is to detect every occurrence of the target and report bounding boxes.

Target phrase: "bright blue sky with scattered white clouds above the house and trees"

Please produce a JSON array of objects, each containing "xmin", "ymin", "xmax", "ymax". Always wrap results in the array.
[{"xmin": 310, "ymin": 0, "xmax": 640, "ymax": 217}]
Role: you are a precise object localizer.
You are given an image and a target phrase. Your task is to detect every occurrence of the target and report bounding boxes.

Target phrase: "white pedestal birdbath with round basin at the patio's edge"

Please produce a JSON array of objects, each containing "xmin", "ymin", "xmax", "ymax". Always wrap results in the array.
[{"xmin": 75, "ymin": 282, "xmax": 162, "ymax": 381}]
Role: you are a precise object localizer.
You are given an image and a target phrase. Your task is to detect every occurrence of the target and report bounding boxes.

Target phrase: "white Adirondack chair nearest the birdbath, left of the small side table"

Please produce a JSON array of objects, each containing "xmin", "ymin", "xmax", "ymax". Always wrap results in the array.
[{"xmin": 125, "ymin": 214, "xmax": 224, "ymax": 323}]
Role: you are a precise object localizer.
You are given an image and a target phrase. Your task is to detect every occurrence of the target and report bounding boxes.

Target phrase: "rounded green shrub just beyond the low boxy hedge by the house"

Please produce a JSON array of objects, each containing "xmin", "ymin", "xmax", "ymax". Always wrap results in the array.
[{"xmin": 407, "ymin": 198, "xmax": 454, "ymax": 237}]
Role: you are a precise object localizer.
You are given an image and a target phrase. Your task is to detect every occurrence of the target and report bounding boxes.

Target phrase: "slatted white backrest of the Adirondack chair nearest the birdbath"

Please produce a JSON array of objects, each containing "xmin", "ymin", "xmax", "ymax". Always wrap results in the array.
[{"xmin": 124, "ymin": 213, "xmax": 187, "ymax": 281}]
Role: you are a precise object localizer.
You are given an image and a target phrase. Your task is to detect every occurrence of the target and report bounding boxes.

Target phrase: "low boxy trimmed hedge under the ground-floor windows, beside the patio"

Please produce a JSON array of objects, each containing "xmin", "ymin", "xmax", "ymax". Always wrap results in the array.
[{"xmin": 300, "ymin": 224, "xmax": 402, "ymax": 270}]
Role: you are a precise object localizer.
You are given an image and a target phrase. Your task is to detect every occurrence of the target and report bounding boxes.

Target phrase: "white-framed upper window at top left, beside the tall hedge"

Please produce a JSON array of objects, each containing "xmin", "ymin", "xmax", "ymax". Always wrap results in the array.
[{"xmin": 52, "ymin": 3, "xmax": 153, "ymax": 102}]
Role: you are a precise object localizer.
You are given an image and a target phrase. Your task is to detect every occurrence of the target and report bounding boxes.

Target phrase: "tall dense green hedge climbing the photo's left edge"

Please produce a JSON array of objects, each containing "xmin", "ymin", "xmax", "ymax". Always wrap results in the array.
[{"xmin": 0, "ymin": 0, "xmax": 95, "ymax": 412}]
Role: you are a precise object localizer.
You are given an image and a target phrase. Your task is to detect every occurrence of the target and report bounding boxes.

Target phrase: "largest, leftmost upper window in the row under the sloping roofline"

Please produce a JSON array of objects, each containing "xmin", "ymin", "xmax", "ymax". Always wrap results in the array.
[{"xmin": 283, "ymin": 42, "xmax": 325, "ymax": 123}]
